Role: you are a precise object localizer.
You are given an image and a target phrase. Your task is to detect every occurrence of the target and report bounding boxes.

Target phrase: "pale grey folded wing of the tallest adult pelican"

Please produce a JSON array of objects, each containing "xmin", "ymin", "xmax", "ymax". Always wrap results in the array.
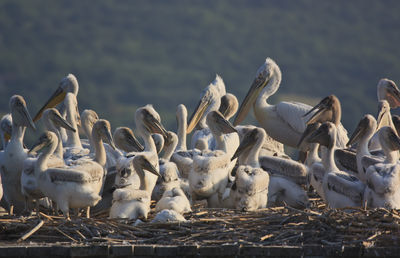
[{"xmin": 275, "ymin": 101, "xmax": 312, "ymax": 134}]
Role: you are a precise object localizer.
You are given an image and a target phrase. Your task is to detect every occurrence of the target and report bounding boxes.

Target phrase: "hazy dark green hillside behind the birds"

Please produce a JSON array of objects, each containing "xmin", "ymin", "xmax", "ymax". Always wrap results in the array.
[{"xmin": 0, "ymin": 0, "xmax": 400, "ymax": 143}]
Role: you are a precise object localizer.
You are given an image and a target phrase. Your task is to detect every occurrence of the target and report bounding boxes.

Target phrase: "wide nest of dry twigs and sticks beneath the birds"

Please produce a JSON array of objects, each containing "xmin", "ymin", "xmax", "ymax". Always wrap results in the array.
[{"xmin": 0, "ymin": 198, "xmax": 400, "ymax": 247}]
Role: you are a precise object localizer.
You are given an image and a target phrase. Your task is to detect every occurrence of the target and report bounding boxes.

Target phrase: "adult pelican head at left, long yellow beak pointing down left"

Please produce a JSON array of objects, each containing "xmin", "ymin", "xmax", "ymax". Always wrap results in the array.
[{"xmin": 33, "ymin": 74, "xmax": 79, "ymax": 122}]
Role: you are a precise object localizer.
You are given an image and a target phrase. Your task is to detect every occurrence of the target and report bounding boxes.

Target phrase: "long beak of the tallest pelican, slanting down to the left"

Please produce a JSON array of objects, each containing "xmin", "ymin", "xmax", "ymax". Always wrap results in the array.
[{"xmin": 233, "ymin": 73, "xmax": 271, "ymax": 126}]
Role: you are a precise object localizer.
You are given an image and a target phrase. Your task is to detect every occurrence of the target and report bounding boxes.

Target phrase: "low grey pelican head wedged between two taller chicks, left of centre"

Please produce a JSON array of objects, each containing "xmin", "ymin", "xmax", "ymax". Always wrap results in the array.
[{"xmin": 113, "ymin": 127, "xmax": 144, "ymax": 152}]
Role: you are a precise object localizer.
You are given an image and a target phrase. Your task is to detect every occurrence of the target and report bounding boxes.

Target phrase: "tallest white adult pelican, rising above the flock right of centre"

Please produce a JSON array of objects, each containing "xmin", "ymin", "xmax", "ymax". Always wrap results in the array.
[{"xmin": 233, "ymin": 58, "xmax": 311, "ymax": 151}]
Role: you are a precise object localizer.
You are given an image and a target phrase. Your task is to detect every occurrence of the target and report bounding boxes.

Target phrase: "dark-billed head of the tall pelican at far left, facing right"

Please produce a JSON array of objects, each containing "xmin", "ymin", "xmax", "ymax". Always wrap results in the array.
[{"xmin": 10, "ymin": 95, "xmax": 36, "ymax": 130}]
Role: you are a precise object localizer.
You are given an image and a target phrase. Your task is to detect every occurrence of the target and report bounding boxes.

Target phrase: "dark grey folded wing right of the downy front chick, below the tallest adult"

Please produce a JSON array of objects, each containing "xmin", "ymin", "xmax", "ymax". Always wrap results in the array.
[{"xmin": 259, "ymin": 156, "xmax": 307, "ymax": 185}]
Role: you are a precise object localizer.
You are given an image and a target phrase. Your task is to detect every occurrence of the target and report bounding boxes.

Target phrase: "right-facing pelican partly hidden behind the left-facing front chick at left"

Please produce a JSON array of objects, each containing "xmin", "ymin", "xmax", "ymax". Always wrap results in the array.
[{"xmin": 21, "ymin": 108, "xmax": 75, "ymax": 213}]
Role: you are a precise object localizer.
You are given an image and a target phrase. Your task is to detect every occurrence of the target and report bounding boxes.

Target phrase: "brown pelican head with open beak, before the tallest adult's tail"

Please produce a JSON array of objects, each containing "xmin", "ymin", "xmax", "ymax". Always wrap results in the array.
[{"xmin": 303, "ymin": 95, "xmax": 341, "ymax": 124}]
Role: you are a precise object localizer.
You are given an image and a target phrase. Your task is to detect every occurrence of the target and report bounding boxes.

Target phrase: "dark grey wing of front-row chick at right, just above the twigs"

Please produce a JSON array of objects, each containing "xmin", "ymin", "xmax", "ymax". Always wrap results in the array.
[{"xmin": 327, "ymin": 172, "xmax": 365, "ymax": 203}]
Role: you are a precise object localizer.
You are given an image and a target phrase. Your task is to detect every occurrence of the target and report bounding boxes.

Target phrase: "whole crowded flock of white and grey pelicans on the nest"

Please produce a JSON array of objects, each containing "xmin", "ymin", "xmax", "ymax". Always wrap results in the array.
[{"xmin": 0, "ymin": 58, "xmax": 400, "ymax": 222}]
